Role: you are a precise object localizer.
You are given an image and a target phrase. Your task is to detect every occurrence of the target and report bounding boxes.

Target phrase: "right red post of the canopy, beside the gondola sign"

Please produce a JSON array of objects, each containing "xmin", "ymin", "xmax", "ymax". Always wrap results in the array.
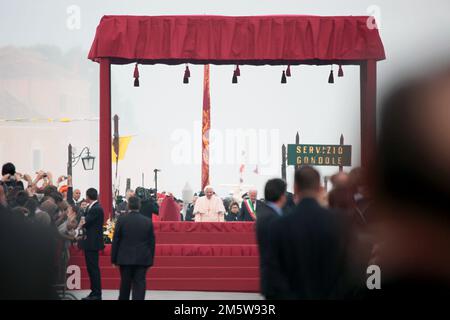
[{"xmin": 360, "ymin": 60, "xmax": 377, "ymax": 168}]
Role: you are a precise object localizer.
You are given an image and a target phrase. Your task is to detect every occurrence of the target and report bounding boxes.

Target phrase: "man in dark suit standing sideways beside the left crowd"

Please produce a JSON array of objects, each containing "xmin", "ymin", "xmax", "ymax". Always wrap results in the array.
[{"xmin": 80, "ymin": 188, "xmax": 105, "ymax": 300}]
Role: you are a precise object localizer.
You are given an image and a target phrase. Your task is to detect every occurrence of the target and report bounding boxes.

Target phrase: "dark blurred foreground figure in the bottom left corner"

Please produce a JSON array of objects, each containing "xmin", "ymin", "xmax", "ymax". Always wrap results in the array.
[{"xmin": 0, "ymin": 205, "xmax": 58, "ymax": 300}]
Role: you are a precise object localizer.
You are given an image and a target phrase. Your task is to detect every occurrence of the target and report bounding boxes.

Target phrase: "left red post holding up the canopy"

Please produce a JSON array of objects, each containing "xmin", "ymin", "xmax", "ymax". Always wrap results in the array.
[{"xmin": 99, "ymin": 58, "xmax": 112, "ymax": 221}]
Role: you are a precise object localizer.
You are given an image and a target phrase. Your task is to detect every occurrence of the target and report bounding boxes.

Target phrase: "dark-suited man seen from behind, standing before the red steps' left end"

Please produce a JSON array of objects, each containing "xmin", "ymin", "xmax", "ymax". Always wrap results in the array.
[{"xmin": 111, "ymin": 197, "xmax": 155, "ymax": 300}]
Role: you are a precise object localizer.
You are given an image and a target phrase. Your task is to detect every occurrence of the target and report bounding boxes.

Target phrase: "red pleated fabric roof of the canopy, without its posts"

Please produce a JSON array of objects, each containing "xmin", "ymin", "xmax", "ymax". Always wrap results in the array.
[{"xmin": 89, "ymin": 15, "xmax": 385, "ymax": 65}]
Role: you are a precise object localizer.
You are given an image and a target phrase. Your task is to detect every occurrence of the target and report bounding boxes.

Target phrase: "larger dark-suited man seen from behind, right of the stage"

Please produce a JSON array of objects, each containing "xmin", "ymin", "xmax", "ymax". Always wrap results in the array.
[{"xmin": 267, "ymin": 166, "xmax": 345, "ymax": 299}]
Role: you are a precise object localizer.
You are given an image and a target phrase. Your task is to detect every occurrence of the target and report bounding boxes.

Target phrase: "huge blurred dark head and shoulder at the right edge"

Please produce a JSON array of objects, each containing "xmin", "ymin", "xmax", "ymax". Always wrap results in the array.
[{"xmin": 372, "ymin": 72, "xmax": 450, "ymax": 298}]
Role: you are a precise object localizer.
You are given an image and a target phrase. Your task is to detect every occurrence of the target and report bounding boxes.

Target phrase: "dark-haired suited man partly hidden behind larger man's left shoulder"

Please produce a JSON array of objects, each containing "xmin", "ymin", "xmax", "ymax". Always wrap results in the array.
[{"xmin": 256, "ymin": 179, "xmax": 286, "ymax": 299}]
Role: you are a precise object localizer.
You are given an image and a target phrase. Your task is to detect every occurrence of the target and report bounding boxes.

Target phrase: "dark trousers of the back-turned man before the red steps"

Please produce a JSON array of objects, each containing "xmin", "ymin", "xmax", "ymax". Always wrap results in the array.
[{"xmin": 119, "ymin": 266, "xmax": 148, "ymax": 300}]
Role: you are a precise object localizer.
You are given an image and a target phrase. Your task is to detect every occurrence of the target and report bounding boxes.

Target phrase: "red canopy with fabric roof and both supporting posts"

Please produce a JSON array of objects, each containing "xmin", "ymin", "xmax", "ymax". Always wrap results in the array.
[{"xmin": 89, "ymin": 15, "xmax": 385, "ymax": 218}]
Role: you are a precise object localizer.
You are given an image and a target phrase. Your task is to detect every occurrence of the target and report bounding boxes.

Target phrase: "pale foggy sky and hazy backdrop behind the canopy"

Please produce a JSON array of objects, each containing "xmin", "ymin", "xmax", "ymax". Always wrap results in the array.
[{"xmin": 0, "ymin": 0, "xmax": 450, "ymax": 196}]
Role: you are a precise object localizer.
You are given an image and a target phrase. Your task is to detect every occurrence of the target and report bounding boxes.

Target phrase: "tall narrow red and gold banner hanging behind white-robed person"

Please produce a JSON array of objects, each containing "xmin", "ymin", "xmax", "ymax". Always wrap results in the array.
[{"xmin": 202, "ymin": 64, "xmax": 211, "ymax": 190}]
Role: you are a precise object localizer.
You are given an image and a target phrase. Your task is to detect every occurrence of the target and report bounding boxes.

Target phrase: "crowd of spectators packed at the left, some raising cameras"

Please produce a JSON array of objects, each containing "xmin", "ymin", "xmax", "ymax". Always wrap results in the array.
[{"xmin": 0, "ymin": 162, "xmax": 103, "ymax": 298}]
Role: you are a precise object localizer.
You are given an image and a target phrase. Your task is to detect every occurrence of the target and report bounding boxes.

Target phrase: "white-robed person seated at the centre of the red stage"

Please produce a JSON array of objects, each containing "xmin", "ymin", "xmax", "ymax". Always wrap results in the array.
[{"xmin": 194, "ymin": 186, "xmax": 225, "ymax": 222}]
